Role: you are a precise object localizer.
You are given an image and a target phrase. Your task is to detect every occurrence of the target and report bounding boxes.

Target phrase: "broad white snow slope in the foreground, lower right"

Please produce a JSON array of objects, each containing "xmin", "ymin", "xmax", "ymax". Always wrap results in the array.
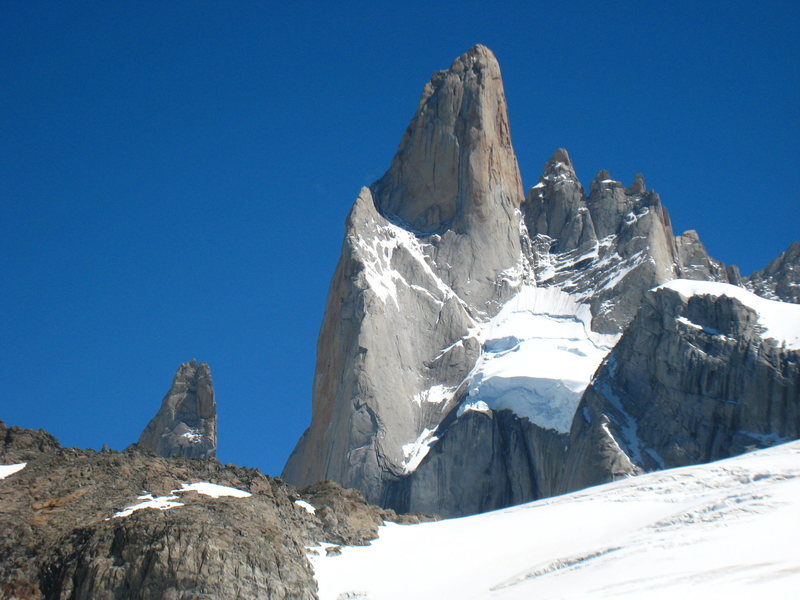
[{"xmin": 311, "ymin": 441, "xmax": 800, "ymax": 600}]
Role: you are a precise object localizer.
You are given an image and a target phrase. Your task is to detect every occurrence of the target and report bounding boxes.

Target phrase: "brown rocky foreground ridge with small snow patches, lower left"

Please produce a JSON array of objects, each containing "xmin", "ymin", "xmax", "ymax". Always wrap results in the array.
[{"xmin": 0, "ymin": 421, "xmax": 432, "ymax": 600}]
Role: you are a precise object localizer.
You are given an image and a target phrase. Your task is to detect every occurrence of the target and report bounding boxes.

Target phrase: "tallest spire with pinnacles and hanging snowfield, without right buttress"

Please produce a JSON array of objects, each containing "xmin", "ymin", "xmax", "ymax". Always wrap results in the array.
[{"xmin": 283, "ymin": 46, "xmax": 756, "ymax": 515}]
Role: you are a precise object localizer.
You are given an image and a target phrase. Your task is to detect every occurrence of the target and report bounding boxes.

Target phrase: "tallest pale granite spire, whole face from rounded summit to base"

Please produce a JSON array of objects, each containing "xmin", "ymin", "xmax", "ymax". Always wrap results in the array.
[{"xmin": 284, "ymin": 46, "xmax": 522, "ymax": 502}]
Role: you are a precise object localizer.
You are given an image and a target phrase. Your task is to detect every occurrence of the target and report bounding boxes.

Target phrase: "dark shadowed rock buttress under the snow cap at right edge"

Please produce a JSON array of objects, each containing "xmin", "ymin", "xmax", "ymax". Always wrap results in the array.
[{"xmin": 559, "ymin": 282, "xmax": 800, "ymax": 492}]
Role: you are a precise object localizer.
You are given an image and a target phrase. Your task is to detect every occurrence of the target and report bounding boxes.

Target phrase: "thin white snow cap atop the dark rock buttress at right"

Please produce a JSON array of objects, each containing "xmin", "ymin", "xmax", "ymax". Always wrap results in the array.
[{"xmin": 659, "ymin": 279, "xmax": 800, "ymax": 350}]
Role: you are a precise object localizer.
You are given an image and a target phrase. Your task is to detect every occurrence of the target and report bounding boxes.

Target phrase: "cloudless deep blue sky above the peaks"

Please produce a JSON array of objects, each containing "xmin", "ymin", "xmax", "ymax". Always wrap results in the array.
[{"xmin": 0, "ymin": 1, "xmax": 800, "ymax": 474}]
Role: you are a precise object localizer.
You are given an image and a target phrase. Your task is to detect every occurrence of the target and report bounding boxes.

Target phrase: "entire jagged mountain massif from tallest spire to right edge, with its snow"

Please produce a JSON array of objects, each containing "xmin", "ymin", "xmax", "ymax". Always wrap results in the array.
[{"xmin": 284, "ymin": 45, "xmax": 800, "ymax": 515}]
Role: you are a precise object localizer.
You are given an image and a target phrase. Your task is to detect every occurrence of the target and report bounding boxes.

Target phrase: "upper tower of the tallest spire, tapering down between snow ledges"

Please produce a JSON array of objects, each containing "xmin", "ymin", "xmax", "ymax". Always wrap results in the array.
[{"xmin": 371, "ymin": 45, "xmax": 522, "ymax": 310}]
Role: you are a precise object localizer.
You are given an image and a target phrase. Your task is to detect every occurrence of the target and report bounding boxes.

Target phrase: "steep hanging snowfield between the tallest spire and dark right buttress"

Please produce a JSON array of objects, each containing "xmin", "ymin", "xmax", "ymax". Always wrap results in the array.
[{"xmin": 459, "ymin": 286, "xmax": 619, "ymax": 433}]
